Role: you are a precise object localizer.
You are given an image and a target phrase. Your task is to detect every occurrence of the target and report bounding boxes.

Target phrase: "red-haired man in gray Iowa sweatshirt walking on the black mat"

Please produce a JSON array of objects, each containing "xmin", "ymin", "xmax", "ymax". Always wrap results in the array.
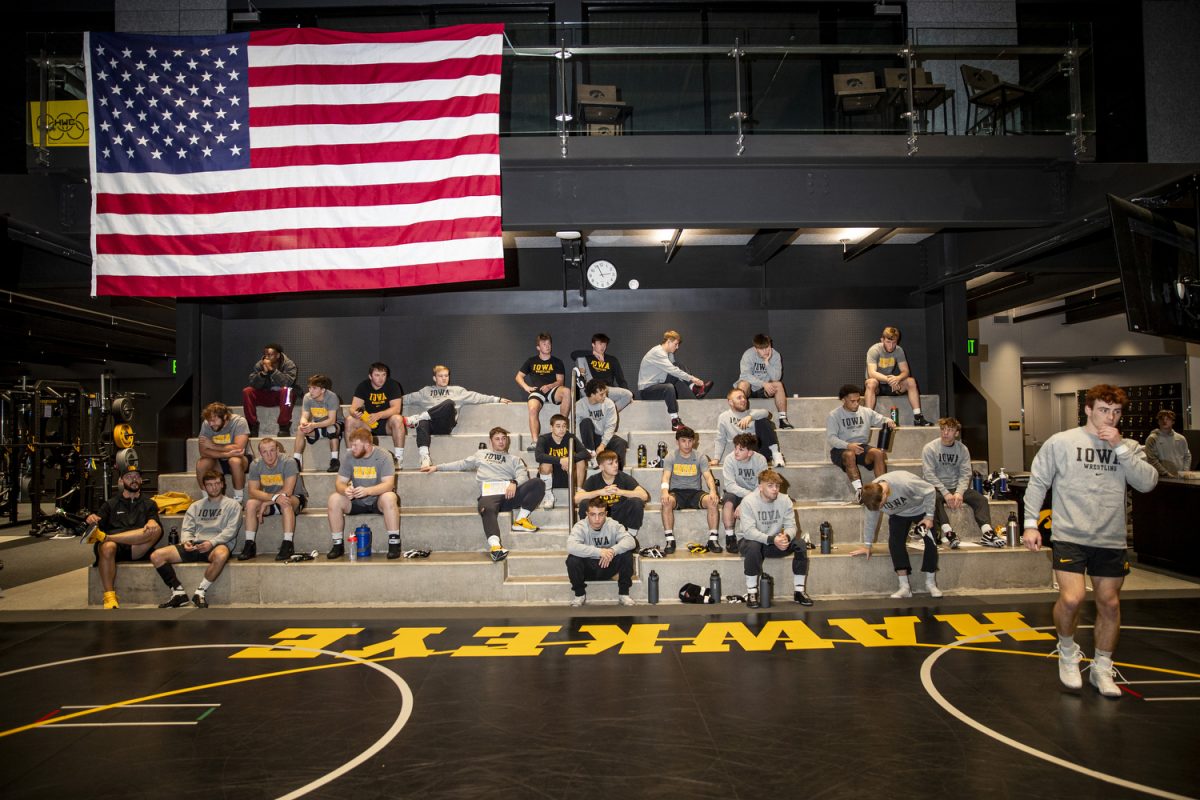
[{"xmin": 1022, "ymin": 384, "xmax": 1158, "ymax": 698}]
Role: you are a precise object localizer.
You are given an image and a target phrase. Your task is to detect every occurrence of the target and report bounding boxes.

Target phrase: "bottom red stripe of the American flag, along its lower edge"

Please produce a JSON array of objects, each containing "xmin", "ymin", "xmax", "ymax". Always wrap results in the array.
[{"xmin": 96, "ymin": 258, "xmax": 504, "ymax": 297}]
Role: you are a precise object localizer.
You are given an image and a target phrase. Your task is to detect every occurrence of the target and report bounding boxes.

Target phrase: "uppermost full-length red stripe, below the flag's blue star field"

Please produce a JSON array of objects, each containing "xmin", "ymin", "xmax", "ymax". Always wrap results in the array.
[{"xmin": 96, "ymin": 175, "xmax": 500, "ymax": 215}]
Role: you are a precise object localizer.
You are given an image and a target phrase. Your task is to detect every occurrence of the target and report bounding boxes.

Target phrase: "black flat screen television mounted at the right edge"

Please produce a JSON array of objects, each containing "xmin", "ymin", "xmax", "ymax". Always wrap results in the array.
[{"xmin": 1109, "ymin": 194, "xmax": 1200, "ymax": 342}]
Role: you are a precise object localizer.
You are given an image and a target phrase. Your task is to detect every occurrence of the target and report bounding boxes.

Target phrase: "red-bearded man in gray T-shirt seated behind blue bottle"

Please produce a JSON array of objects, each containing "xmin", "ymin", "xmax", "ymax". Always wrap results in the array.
[{"xmin": 325, "ymin": 427, "xmax": 400, "ymax": 560}]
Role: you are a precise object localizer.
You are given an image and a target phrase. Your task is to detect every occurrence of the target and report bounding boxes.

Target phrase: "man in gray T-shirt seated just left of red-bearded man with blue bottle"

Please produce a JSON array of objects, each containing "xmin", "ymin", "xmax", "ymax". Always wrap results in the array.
[{"xmin": 238, "ymin": 437, "xmax": 308, "ymax": 561}]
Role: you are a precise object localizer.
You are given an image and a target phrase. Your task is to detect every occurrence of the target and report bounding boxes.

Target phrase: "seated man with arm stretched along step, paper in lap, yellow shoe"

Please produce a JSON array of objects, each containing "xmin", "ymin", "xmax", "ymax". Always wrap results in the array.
[{"xmin": 421, "ymin": 427, "xmax": 546, "ymax": 563}]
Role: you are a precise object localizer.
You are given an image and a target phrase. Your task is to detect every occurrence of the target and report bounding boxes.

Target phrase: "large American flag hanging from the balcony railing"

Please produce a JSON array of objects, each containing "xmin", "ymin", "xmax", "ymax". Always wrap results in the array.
[{"xmin": 84, "ymin": 25, "xmax": 504, "ymax": 296}]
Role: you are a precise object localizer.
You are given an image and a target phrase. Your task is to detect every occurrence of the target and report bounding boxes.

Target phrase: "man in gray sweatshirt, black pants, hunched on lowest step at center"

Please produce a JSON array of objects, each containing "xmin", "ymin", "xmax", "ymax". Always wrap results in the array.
[{"xmin": 566, "ymin": 498, "xmax": 637, "ymax": 608}]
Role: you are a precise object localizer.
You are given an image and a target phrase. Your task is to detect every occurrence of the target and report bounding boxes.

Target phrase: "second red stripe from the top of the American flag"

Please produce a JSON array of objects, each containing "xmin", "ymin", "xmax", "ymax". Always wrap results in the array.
[{"xmin": 247, "ymin": 55, "xmax": 500, "ymax": 88}]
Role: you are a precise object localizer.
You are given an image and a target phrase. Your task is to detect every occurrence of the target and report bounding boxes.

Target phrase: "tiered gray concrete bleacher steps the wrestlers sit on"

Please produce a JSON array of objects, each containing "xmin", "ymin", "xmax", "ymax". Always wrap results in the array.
[{"xmin": 89, "ymin": 397, "xmax": 1050, "ymax": 606}]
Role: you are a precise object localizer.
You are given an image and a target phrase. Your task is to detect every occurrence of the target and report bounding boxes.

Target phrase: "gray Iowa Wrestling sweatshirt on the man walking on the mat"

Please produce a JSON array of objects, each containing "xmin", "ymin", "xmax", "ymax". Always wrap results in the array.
[{"xmin": 1025, "ymin": 427, "xmax": 1158, "ymax": 549}]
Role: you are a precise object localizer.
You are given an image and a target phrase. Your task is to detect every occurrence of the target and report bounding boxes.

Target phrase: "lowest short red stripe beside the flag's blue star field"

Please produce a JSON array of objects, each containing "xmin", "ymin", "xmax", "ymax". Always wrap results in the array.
[{"xmin": 250, "ymin": 133, "xmax": 500, "ymax": 169}]
